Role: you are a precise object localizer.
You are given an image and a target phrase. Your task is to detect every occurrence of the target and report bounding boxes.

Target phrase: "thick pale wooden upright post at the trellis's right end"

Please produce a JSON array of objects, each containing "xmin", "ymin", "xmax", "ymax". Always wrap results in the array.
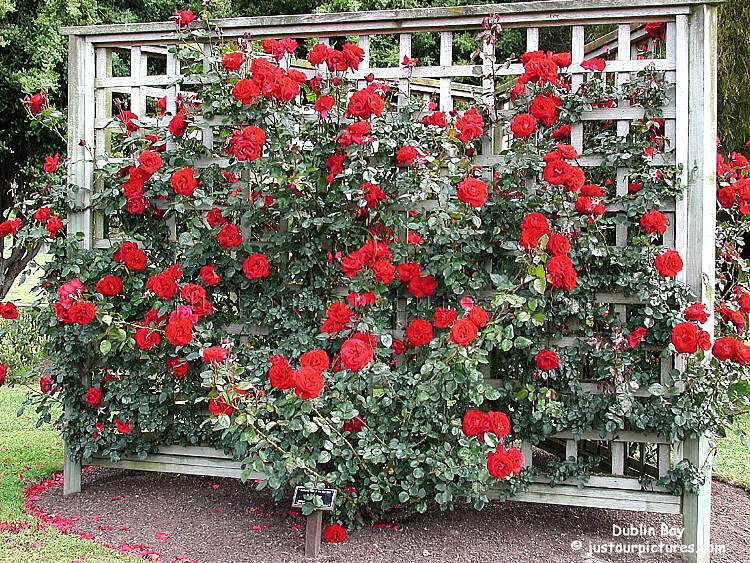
[{"xmin": 682, "ymin": 5, "xmax": 717, "ymax": 563}]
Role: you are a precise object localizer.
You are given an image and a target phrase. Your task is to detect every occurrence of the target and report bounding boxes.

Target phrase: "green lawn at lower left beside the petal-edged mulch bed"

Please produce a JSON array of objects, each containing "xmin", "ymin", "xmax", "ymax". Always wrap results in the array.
[{"xmin": 0, "ymin": 387, "xmax": 142, "ymax": 563}]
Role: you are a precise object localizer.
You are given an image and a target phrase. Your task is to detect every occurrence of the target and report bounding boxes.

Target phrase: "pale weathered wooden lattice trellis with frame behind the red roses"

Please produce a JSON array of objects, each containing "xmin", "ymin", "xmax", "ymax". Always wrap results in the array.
[{"xmin": 63, "ymin": 0, "xmax": 718, "ymax": 561}]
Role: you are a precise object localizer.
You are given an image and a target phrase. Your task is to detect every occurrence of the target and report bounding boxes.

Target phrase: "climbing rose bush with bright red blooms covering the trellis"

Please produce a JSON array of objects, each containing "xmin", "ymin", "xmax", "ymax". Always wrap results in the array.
[{"xmin": 0, "ymin": 15, "xmax": 750, "ymax": 532}]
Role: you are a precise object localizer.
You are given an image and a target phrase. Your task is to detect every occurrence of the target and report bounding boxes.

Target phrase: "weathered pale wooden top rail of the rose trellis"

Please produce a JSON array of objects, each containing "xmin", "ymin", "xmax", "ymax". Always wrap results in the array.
[{"xmin": 60, "ymin": 0, "xmax": 724, "ymax": 37}]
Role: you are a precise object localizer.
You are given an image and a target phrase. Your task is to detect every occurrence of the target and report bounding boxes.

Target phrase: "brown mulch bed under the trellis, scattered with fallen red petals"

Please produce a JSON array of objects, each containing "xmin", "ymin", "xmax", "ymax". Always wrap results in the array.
[{"xmin": 30, "ymin": 469, "xmax": 750, "ymax": 563}]
